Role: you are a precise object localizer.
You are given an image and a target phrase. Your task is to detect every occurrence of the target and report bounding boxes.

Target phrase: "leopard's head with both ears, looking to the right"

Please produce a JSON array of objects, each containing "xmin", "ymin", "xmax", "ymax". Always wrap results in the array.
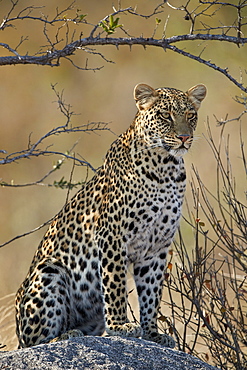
[{"xmin": 134, "ymin": 84, "xmax": 206, "ymax": 157}]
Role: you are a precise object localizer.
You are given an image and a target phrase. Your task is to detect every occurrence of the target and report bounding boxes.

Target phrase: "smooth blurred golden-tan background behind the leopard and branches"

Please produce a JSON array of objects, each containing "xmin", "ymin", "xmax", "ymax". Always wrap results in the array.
[{"xmin": 0, "ymin": 0, "xmax": 247, "ymax": 349}]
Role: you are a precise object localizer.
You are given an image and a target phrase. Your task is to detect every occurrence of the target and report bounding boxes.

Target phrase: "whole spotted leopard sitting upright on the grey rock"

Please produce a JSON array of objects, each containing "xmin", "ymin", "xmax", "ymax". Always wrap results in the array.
[{"xmin": 16, "ymin": 83, "xmax": 206, "ymax": 348}]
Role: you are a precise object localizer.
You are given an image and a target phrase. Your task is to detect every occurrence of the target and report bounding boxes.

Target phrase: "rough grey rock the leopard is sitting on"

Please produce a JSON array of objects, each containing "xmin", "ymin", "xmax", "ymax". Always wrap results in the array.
[{"xmin": 0, "ymin": 336, "xmax": 219, "ymax": 370}]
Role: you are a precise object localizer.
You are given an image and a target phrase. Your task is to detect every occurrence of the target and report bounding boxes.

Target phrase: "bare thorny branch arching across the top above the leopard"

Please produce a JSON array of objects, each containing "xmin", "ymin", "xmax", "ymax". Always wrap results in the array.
[{"xmin": 0, "ymin": 0, "xmax": 247, "ymax": 93}]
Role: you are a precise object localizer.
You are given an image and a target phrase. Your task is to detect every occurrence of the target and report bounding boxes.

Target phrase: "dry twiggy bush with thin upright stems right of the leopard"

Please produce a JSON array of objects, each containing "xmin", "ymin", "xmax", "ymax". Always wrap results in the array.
[{"xmin": 161, "ymin": 120, "xmax": 247, "ymax": 370}]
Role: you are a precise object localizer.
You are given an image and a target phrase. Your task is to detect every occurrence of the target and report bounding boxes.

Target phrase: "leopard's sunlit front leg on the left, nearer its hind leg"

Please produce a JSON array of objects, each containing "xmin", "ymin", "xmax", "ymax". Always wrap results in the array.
[{"xmin": 99, "ymin": 240, "xmax": 142, "ymax": 337}]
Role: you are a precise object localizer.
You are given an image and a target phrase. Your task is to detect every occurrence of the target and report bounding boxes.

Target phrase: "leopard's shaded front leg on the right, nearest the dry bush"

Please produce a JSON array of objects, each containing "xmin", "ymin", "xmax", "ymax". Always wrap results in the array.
[{"xmin": 134, "ymin": 251, "xmax": 175, "ymax": 348}]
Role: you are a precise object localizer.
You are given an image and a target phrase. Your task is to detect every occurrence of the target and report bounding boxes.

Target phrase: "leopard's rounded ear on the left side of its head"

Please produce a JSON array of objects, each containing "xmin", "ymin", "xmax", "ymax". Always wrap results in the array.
[{"xmin": 134, "ymin": 84, "xmax": 159, "ymax": 110}]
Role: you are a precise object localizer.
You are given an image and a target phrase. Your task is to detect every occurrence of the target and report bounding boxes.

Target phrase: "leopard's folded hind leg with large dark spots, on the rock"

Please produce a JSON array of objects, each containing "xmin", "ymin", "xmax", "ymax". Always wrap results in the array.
[{"xmin": 16, "ymin": 260, "xmax": 81, "ymax": 347}]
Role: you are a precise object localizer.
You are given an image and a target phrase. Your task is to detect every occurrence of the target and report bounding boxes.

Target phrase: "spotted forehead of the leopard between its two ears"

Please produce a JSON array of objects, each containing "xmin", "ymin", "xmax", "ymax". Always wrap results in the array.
[{"xmin": 156, "ymin": 87, "xmax": 193, "ymax": 111}]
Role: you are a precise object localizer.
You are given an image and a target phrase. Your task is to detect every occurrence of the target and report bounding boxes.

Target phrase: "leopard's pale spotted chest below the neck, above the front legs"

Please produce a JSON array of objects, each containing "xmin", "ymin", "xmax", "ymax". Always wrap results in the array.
[{"xmin": 121, "ymin": 162, "xmax": 185, "ymax": 262}]
